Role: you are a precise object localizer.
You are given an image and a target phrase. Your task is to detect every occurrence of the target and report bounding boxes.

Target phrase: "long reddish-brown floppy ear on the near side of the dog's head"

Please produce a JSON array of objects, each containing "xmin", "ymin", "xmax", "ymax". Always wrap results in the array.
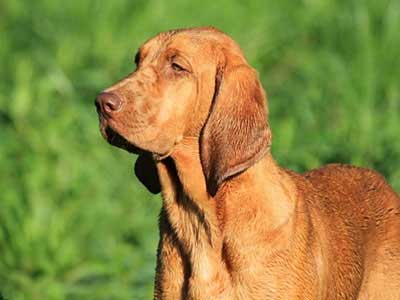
[{"xmin": 200, "ymin": 64, "xmax": 271, "ymax": 196}]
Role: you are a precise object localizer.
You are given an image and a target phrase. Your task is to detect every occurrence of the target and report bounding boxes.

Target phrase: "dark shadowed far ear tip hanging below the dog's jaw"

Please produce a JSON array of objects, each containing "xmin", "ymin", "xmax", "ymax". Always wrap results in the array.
[{"xmin": 135, "ymin": 152, "xmax": 161, "ymax": 194}]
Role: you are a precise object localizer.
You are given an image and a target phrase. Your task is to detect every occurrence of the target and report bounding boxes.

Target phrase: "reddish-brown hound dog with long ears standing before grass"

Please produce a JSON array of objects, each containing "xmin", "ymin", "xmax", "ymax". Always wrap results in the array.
[{"xmin": 96, "ymin": 28, "xmax": 400, "ymax": 300}]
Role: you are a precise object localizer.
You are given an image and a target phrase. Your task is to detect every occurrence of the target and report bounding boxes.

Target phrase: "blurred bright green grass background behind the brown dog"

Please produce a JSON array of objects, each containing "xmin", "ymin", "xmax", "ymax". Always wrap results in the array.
[{"xmin": 0, "ymin": 0, "xmax": 400, "ymax": 300}]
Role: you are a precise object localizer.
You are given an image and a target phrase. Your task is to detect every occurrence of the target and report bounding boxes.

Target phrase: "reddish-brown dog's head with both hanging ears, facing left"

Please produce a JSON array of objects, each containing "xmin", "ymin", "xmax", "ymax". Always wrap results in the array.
[{"xmin": 96, "ymin": 27, "xmax": 271, "ymax": 194}]
